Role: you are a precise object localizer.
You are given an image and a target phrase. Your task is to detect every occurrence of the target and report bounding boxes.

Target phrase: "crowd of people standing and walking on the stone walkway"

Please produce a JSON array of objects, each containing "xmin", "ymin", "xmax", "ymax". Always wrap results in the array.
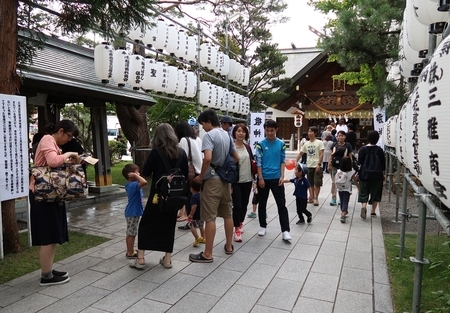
[{"xmin": 30, "ymin": 114, "xmax": 385, "ymax": 286}]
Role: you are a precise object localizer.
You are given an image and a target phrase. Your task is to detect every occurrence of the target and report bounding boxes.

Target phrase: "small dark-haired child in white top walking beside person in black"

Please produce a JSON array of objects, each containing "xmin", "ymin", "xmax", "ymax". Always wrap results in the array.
[{"xmin": 335, "ymin": 156, "xmax": 359, "ymax": 223}]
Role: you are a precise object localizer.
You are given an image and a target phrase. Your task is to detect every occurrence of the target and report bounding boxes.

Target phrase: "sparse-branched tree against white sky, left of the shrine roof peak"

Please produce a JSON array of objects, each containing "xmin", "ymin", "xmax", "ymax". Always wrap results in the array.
[{"xmin": 214, "ymin": 0, "xmax": 292, "ymax": 111}]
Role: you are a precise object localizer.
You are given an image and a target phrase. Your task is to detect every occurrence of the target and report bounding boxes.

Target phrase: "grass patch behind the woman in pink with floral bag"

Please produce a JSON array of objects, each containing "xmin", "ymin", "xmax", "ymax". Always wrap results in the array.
[{"xmin": 0, "ymin": 231, "xmax": 109, "ymax": 284}]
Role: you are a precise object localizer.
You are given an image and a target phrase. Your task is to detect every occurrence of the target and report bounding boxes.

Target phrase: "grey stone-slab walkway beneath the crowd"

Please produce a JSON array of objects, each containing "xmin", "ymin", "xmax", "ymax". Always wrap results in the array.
[{"xmin": 0, "ymin": 172, "xmax": 393, "ymax": 313}]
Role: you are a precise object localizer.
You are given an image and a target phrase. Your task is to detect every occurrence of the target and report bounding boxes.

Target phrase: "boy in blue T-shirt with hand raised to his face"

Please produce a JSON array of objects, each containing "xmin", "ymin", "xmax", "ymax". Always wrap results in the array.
[{"xmin": 122, "ymin": 164, "xmax": 147, "ymax": 259}]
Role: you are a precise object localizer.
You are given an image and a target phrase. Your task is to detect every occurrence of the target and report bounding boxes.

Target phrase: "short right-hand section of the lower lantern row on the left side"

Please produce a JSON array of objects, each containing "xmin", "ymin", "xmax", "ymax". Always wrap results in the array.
[{"xmin": 199, "ymin": 81, "xmax": 250, "ymax": 115}]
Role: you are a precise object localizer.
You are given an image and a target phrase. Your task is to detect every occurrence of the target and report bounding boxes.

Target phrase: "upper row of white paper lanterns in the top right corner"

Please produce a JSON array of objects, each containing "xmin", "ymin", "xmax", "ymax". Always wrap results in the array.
[{"xmin": 399, "ymin": 0, "xmax": 449, "ymax": 78}]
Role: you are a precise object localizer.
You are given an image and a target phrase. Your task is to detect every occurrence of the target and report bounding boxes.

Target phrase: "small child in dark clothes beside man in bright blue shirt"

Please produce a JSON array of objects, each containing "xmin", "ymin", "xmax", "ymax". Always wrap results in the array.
[{"xmin": 284, "ymin": 161, "xmax": 312, "ymax": 224}]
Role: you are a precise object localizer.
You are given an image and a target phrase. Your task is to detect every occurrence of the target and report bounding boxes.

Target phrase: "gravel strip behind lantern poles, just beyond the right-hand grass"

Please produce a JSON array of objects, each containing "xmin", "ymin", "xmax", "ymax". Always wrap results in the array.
[{"xmin": 379, "ymin": 183, "xmax": 445, "ymax": 234}]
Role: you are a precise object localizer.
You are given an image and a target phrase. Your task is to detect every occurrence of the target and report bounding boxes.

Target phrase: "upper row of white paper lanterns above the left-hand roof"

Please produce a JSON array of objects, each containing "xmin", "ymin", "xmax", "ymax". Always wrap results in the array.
[{"xmin": 128, "ymin": 19, "xmax": 250, "ymax": 86}]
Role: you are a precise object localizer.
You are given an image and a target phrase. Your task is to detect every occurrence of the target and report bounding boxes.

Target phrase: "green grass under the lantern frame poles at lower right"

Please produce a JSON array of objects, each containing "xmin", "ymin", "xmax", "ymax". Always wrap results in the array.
[{"xmin": 384, "ymin": 234, "xmax": 450, "ymax": 312}]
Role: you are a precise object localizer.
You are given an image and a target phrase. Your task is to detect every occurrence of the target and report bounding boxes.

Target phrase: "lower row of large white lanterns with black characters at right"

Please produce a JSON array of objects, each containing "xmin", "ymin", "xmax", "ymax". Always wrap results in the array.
[{"xmin": 383, "ymin": 31, "xmax": 450, "ymax": 206}]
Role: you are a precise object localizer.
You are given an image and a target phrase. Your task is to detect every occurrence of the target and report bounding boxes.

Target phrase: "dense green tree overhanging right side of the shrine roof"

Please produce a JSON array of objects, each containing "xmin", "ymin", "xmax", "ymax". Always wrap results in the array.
[{"xmin": 309, "ymin": 0, "xmax": 406, "ymax": 112}]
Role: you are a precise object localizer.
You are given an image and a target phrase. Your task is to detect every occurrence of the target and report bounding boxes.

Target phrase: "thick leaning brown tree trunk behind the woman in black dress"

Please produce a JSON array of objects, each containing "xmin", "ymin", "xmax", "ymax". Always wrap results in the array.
[{"xmin": 116, "ymin": 103, "xmax": 150, "ymax": 169}]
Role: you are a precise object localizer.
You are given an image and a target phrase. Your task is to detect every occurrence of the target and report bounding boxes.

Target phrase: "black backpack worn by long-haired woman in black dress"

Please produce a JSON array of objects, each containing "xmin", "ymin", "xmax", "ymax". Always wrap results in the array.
[{"xmin": 155, "ymin": 149, "xmax": 188, "ymax": 212}]
